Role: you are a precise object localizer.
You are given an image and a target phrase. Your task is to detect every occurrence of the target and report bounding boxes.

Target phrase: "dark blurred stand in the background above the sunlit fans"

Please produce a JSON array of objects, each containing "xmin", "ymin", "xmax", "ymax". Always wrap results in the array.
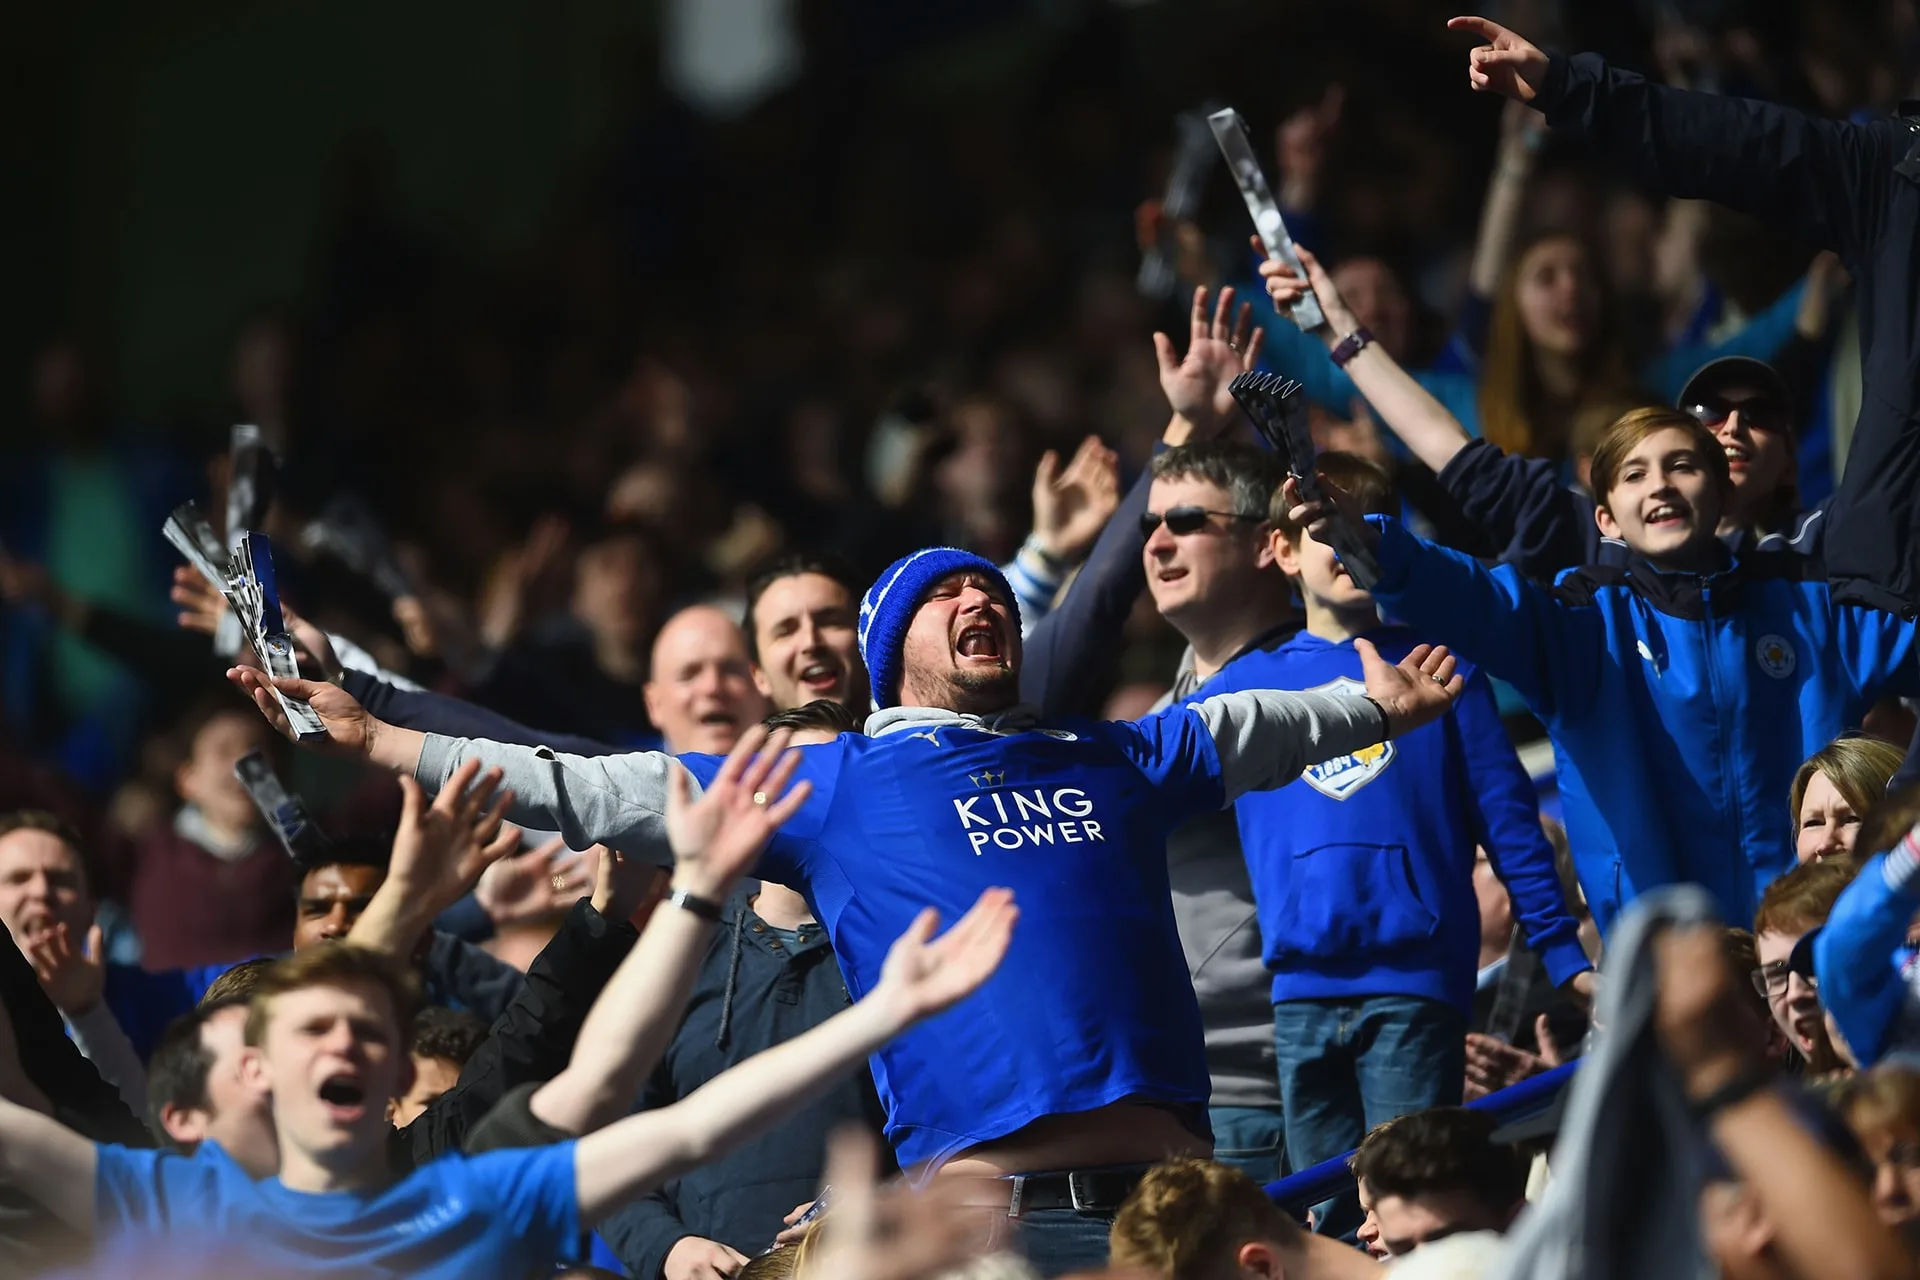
[{"xmin": 0, "ymin": 0, "xmax": 1914, "ymax": 802}]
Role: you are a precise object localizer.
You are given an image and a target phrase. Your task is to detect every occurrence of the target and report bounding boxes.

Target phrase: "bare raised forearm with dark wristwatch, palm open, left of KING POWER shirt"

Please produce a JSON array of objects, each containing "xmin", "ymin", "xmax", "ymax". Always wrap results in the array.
[{"xmin": 530, "ymin": 727, "xmax": 812, "ymax": 1134}]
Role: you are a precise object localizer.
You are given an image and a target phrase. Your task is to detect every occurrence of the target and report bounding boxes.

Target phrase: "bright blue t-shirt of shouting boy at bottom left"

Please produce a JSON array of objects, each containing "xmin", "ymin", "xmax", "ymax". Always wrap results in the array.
[{"xmin": 94, "ymin": 1142, "xmax": 580, "ymax": 1280}]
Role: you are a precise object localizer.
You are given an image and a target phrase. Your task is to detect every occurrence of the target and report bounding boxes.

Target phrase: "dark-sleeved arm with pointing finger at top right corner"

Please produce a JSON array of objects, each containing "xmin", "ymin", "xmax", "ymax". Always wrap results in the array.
[{"xmin": 1448, "ymin": 17, "xmax": 1905, "ymax": 265}]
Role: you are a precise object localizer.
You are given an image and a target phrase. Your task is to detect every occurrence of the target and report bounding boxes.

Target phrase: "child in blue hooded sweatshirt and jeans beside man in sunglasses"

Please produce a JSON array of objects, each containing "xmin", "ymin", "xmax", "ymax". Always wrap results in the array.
[{"xmin": 1198, "ymin": 453, "xmax": 1592, "ymax": 1220}]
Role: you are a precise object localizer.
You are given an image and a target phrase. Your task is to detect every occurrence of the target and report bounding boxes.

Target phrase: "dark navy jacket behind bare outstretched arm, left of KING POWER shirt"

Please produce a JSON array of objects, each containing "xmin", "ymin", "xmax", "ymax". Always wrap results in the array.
[{"xmin": 599, "ymin": 890, "xmax": 881, "ymax": 1280}]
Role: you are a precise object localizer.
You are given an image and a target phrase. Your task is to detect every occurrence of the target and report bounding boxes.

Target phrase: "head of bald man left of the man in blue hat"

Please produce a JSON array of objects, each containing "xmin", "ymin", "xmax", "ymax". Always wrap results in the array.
[{"xmin": 647, "ymin": 604, "xmax": 772, "ymax": 756}]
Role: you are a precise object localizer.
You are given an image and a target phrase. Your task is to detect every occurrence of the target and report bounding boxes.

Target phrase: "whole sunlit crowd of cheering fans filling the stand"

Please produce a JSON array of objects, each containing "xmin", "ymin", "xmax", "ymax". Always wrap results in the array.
[{"xmin": 0, "ymin": 4, "xmax": 1920, "ymax": 1280}]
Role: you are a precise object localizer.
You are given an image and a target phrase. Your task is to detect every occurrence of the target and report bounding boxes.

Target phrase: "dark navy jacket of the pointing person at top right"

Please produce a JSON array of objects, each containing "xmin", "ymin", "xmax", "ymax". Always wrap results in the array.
[{"xmin": 1534, "ymin": 54, "xmax": 1920, "ymax": 618}]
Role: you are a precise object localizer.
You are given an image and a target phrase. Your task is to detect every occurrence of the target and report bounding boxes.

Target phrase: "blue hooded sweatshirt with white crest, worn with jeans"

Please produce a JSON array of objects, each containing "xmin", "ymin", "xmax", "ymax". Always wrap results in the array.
[{"xmin": 1200, "ymin": 628, "xmax": 1592, "ymax": 1013}]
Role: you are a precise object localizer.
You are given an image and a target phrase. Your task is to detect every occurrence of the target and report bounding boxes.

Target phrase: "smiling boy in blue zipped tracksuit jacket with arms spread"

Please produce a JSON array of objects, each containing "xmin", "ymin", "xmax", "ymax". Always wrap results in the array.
[{"xmin": 1298, "ymin": 404, "xmax": 1916, "ymax": 929}]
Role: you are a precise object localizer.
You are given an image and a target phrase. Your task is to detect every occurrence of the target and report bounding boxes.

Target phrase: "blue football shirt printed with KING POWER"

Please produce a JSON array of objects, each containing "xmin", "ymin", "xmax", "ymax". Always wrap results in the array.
[{"xmin": 682, "ymin": 706, "xmax": 1225, "ymax": 1167}]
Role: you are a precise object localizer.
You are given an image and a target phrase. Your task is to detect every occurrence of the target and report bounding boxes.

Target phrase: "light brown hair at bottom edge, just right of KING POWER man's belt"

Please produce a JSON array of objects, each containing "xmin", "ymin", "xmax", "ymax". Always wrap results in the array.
[{"xmin": 1108, "ymin": 1159, "xmax": 1302, "ymax": 1280}]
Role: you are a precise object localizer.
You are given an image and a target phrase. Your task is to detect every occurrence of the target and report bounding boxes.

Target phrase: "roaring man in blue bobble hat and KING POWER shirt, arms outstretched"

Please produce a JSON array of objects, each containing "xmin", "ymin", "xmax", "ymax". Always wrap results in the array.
[{"xmin": 234, "ymin": 547, "xmax": 1461, "ymax": 1274}]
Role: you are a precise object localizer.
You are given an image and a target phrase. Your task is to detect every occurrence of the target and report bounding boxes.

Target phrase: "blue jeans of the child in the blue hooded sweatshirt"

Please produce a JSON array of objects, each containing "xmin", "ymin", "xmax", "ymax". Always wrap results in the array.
[{"xmin": 1273, "ymin": 996, "xmax": 1467, "ymax": 1236}]
